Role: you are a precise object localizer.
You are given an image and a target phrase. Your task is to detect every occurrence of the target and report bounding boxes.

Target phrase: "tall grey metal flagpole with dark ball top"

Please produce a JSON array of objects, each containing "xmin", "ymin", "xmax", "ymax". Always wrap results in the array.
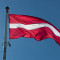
[{"xmin": 3, "ymin": 7, "xmax": 9, "ymax": 60}]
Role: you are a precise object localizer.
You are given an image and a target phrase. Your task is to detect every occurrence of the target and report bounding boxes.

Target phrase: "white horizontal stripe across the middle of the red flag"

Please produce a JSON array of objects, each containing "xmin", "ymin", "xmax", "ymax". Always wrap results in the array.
[{"xmin": 9, "ymin": 23, "xmax": 60, "ymax": 37}]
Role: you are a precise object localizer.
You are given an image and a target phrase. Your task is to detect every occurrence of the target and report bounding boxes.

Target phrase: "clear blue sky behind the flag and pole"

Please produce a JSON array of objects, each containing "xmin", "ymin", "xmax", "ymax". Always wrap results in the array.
[{"xmin": 0, "ymin": 0, "xmax": 60, "ymax": 60}]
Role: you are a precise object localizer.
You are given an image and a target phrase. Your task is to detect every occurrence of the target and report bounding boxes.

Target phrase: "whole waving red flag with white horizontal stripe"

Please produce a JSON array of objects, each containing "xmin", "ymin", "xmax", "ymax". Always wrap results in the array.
[{"xmin": 9, "ymin": 14, "xmax": 60, "ymax": 44}]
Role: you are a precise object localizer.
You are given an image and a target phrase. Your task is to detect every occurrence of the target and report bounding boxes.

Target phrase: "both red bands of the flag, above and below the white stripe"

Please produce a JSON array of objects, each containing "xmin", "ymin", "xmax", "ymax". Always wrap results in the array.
[{"xmin": 9, "ymin": 14, "xmax": 60, "ymax": 44}]
